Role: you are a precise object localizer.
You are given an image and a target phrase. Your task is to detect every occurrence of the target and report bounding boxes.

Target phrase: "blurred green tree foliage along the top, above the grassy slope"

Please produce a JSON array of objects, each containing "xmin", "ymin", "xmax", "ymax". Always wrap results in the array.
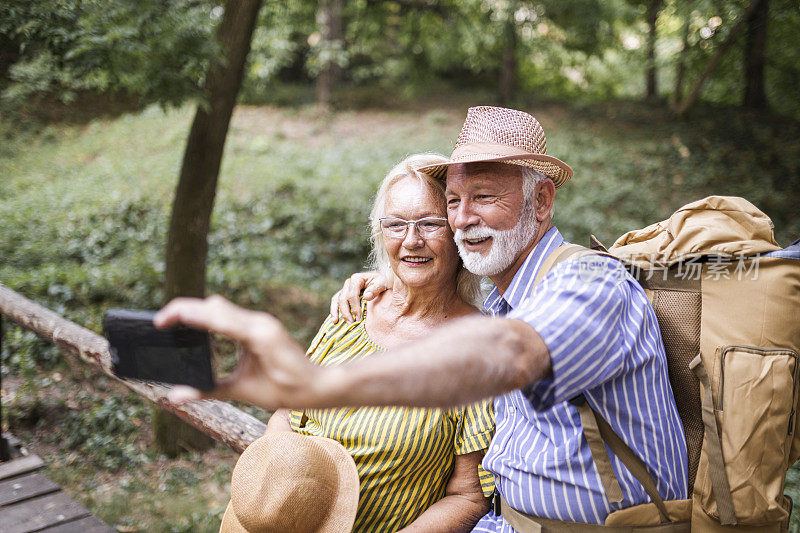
[{"xmin": 0, "ymin": 0, "xmax": 800, "ymax": 118}]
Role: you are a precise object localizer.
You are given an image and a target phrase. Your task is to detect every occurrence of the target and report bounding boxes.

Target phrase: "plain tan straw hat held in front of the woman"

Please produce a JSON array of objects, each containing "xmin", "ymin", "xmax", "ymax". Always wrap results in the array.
[{"xmin": 220, "ymin": 431, "xmax": 359, "ymax": 533}]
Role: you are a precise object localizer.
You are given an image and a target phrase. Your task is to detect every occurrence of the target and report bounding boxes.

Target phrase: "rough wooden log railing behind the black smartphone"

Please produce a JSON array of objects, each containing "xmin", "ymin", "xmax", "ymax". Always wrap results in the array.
[{"xmin": 0, "ymin": 284, "xmax": 266, "ymax": 452}]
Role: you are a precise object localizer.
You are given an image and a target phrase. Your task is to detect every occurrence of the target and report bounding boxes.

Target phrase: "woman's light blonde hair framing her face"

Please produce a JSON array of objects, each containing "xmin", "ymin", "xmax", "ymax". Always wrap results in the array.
[{"xmin": 369, "ymin": 153, "xmax": 481, "ymax": 305}]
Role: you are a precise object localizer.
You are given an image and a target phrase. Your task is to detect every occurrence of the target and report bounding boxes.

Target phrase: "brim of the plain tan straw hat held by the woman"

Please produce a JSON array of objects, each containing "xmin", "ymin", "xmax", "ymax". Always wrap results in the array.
[{"xmin": 219, "ymin": 433, "xmax": 361, "ymax": 533}]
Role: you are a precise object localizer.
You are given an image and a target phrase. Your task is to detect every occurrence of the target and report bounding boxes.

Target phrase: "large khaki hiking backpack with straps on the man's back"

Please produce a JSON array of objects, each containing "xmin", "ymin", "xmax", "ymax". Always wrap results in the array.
[{"xmin": 536, "ymin": 196, "xmax": 800, "ymax": 533}]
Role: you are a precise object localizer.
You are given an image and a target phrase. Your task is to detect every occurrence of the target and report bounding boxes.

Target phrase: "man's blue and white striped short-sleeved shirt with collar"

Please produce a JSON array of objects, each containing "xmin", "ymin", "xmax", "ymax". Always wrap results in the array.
[{"xmin": 474, "ymin": 228, "xmax": 687, "ymax": 533}]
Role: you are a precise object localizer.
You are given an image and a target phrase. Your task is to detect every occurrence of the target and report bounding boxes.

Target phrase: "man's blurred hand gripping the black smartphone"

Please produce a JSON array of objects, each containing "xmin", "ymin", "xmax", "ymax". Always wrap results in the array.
[{"xmin": 153, "ymin": 296, "xmax": 320, "ymax": 409}]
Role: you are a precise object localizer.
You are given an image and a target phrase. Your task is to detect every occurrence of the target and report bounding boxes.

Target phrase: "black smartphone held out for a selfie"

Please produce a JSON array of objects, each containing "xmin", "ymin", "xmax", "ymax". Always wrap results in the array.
[{"xmin": 103, "ymin": 309, "xmax": 214, "ymax": 391}]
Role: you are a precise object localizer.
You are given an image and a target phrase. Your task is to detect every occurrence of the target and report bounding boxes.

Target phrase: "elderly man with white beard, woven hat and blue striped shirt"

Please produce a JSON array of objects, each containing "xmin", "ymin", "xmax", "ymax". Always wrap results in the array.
[{"xmin": 156, "ymin": 107, "xmax": 687, "ymax": 532}]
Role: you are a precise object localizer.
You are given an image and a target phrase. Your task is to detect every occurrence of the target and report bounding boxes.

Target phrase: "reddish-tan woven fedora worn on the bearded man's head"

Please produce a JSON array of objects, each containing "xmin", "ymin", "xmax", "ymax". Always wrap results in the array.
[{"xmin": 419, "ymin": 106, "xmax": 572, "ymax": 189}]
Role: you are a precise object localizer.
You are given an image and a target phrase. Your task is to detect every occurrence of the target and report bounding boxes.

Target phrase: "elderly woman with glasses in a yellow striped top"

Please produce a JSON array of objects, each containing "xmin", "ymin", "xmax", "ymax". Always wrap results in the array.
[{"xmin": 267, "ymin": 154, "xmax": 494, "ymax": 531}]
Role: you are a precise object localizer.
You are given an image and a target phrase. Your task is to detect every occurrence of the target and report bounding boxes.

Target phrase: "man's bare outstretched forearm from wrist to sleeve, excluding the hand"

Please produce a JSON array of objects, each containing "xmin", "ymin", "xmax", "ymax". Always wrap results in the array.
[{"xmin": 320, "ymin": 317, "xmax": 550, "ymax": 407}]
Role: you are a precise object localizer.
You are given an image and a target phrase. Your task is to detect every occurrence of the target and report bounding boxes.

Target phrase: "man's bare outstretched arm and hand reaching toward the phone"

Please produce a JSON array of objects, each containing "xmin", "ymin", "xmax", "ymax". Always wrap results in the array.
[{"xmin": 154, "ymin": 296, "xmax": 550, "ymax": 409}]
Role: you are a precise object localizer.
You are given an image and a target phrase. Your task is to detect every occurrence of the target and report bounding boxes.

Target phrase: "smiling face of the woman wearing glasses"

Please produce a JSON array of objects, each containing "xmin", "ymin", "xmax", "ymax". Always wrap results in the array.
[{"xmin": 383, "ymin": 177, "xmax": 460, "ymax": 290}]
